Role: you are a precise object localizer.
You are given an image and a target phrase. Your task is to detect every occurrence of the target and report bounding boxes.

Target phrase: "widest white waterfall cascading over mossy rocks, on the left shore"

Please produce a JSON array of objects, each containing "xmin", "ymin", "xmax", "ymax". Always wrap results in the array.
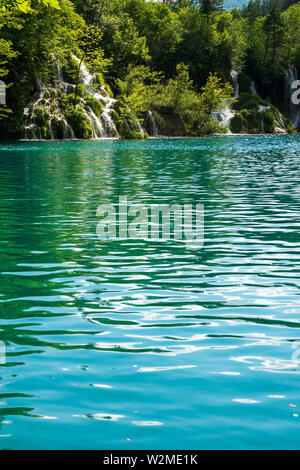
[{"xmin": 24, "ymin": 56, "xmax": 120, "ymax": 140}]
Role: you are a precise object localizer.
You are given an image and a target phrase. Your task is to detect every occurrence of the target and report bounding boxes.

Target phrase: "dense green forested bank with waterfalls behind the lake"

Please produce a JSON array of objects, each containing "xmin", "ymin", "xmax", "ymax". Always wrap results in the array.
[{"xmin": 0, "ymin": 0, "xmax": 300, "ymax": 140}]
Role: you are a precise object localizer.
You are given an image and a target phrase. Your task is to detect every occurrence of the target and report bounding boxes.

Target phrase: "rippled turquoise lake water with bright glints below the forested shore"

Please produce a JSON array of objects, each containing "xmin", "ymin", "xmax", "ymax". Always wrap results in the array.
[{"xmin": 0, "ymin": 135, "xmax": 300, "ymax": 450}]
